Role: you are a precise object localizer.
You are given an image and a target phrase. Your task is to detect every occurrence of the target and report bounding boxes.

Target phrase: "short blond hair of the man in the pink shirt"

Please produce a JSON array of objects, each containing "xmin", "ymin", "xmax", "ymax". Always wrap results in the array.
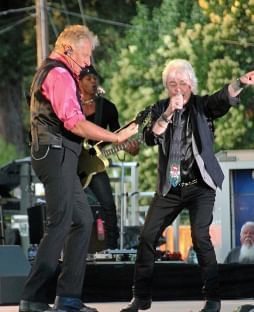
[{"xmin": 55, "ymin": 25, "xmax": 99, "ymax": 50}]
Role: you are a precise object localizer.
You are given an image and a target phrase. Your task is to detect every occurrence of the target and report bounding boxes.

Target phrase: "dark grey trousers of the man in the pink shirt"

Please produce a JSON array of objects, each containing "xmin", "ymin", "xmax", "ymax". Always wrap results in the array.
[{"xmin": 22, "ymin": 146, "xmax": 93, "ymax": 302}]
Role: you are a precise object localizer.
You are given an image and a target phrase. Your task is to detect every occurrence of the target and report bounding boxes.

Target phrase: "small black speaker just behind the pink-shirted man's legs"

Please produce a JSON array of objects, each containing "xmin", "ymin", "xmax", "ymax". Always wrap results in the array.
[{"xmin": 27, "ymin": 204, "xmax": 46, "ymax": 245}]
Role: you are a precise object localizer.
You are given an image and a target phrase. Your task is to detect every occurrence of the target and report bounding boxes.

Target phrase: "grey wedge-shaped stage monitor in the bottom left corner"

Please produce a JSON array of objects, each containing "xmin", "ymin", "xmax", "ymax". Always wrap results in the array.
[{"xmin": 0, "ymin": 245, "xmax": 31, "ymax": 305}]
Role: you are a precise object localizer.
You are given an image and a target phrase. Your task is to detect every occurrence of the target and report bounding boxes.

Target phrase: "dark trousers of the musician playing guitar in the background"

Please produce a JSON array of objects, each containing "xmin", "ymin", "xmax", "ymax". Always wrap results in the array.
[{"xmin": 89, "ymin": 171, "xmax": 119, "ymax": 249}]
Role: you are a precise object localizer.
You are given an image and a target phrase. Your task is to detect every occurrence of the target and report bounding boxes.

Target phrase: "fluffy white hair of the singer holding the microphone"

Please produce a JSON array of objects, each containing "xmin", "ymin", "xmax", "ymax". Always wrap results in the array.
[{"xmin": 162, "ymin": 59, "xmax": 198, "ymax": 94}]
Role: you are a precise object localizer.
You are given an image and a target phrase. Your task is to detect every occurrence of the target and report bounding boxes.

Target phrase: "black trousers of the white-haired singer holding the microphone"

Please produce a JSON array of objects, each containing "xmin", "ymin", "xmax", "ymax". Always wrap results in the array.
[{"xmin": 134, "ymin": 183, "xmax": 219, "ymax": 300}]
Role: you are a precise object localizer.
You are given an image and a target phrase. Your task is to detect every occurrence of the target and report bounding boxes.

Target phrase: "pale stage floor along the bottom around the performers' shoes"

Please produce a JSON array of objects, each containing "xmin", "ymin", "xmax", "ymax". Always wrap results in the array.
[{"xmin": 0, "ymin": 300, "xmax": 254, "ymax": 312}]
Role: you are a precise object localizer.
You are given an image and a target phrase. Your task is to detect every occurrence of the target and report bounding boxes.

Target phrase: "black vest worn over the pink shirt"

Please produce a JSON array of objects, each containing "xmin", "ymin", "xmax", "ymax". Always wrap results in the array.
[{"xmin": 30, "ymin": 59, "xmax": 82, "ymax": 154}]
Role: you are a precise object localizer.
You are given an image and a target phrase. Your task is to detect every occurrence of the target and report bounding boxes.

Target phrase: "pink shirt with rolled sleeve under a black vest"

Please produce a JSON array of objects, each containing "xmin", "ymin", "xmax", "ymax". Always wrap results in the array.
[{"xmin": 42, "ymin": 54, "xmax": 85, "ymax": 131}]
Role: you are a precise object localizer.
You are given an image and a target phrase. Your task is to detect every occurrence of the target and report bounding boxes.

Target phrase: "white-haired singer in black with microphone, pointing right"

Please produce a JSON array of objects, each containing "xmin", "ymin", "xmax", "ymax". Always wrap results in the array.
[{"xmin": 121, "ymin": 59, "xmax": 254, "ymax": 312}]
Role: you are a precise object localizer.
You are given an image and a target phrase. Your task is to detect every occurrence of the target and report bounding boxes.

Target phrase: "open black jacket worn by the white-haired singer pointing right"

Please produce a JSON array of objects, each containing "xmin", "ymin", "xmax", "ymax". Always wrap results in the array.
[{"xmin": 144, "ymin": 85, "xmax": 239, "ymax": 195}]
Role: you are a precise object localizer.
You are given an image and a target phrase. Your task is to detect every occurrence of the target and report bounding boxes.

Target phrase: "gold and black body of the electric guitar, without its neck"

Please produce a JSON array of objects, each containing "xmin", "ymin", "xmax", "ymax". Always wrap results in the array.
[{"xmin": 78, "ymin": 145, "xmax": 109, "ymax": 189}]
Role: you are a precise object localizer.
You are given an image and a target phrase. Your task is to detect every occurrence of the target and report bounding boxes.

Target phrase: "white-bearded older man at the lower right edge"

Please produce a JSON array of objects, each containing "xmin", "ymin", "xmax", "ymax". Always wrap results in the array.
[{"xmin": 224, "ymin": 221, "xmax": 254, "ymax": 264}]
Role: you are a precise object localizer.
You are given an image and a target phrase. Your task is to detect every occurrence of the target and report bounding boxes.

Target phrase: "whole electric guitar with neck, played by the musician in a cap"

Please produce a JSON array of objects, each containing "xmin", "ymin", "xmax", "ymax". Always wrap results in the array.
[{"xmin": 78, "ymin": 107, "xmax": 151, "ymax": 189}]
